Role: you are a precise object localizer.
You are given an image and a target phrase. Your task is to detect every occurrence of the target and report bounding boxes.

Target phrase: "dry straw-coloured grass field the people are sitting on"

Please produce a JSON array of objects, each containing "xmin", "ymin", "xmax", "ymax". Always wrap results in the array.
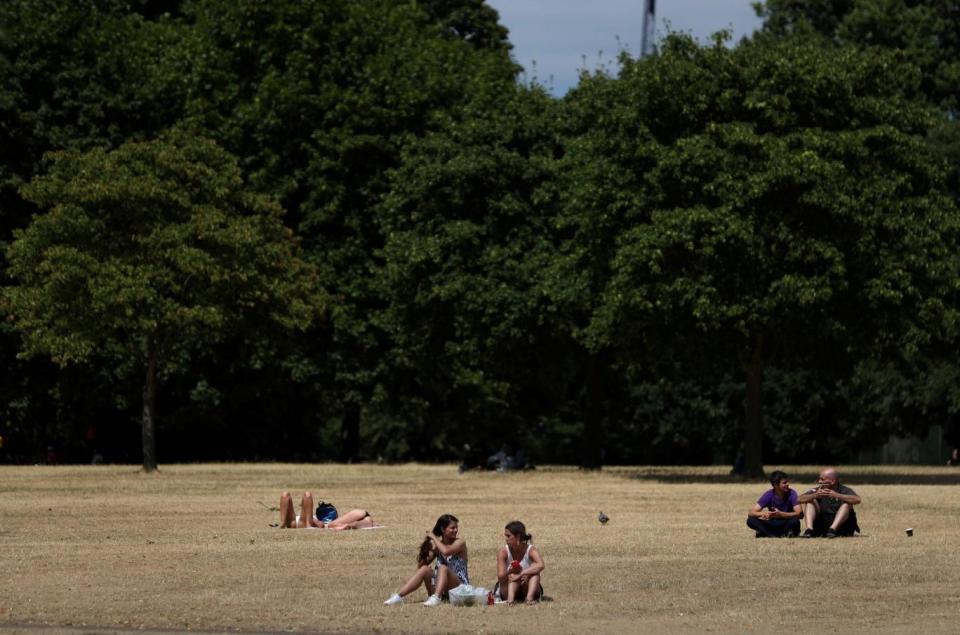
[{"xmin": 0, "ymin": 464, "xmax": 960, "ymax": 634}]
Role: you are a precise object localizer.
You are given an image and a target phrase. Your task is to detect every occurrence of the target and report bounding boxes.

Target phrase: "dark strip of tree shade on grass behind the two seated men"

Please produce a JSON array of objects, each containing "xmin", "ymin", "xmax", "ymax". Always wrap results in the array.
[{"xmin": 630, "ymin": 468, "xmax": 960, "ymax": 486}]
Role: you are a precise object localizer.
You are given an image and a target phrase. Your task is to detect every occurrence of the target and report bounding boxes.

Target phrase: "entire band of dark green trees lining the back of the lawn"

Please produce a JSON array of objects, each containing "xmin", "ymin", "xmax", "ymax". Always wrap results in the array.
[{"xmin": 0, "ymin": 0, "xmax": 960, "ymax": 473}]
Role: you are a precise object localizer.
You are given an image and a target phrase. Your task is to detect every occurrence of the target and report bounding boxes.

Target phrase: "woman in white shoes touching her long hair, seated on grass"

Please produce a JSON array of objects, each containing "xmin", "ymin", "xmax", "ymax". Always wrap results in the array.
[{"xmin": 384, "ymin": 514, "xmax": 470, "ymax": 606}]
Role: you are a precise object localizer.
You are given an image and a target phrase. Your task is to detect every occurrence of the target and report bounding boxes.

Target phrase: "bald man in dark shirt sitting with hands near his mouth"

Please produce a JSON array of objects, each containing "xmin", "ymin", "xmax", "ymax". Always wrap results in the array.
[{"xmin": 797, "ymin": 467, "xmax": 860, "ymax": 538}]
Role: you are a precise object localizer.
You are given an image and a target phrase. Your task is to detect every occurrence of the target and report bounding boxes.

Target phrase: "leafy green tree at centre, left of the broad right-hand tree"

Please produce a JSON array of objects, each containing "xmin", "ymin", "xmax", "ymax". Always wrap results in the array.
[{"xmin": 371, "ymin": 88, "xmax": 567, "ymax": 458}]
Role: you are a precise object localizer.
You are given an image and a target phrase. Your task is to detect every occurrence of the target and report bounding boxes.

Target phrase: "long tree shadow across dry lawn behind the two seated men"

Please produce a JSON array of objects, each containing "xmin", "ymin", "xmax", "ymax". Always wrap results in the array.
[{"xmin": 626, "ymin": 465, "xmax": 960, "ymax": 491}]
